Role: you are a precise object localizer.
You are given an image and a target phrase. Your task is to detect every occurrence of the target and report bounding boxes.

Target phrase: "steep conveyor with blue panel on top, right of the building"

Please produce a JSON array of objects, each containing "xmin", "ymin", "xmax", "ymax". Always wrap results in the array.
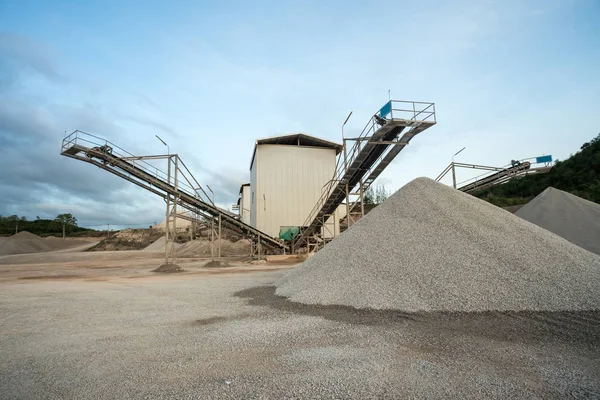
[{"xmin": 294, "ymin": 100, "xmax": 436, "ymax": 247}]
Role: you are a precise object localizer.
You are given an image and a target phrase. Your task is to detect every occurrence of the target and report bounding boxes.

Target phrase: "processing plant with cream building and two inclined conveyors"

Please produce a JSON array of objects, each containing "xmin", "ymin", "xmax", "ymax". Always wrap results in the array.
[{"xmin": 61, "ymin": 100, "xmax": 436, "ymax": 264}]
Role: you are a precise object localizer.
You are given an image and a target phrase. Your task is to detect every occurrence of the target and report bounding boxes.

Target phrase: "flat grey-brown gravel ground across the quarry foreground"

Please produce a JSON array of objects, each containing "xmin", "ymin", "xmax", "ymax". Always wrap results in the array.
[{"xmin": 0, "ymin": 251, "xmax": 600, "ymax": 399}]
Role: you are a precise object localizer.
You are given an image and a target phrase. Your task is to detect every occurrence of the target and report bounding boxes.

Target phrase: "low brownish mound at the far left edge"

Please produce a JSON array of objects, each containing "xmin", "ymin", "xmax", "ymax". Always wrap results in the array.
[{"xmin": 0, "ymin": 231, "xmax": 89, "ymax": 256}]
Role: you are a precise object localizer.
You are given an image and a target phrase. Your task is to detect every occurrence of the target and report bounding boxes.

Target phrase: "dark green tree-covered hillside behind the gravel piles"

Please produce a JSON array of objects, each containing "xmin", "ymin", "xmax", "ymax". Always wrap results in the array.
[{"xmin": 473, "ymin": 134, "xmax": 600, "ymax": 207}]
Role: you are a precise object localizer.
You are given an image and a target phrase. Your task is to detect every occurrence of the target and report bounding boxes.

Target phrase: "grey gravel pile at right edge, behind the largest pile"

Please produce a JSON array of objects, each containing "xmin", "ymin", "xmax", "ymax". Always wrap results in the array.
[{"xmin": 515, "ymin": 187, "xmax": 600, "ymax": 254}]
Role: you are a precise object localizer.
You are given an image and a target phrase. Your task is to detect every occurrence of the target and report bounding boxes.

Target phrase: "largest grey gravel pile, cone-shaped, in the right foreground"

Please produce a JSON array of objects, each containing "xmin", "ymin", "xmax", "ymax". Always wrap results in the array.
[{"xmin": 276, "ymin": 178, "xmax": 600, "ymax": 312}]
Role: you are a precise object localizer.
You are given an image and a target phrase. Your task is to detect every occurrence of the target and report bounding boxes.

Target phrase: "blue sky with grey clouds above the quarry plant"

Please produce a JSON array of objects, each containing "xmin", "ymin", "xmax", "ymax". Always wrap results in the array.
[{"xmin": 0, "ymin": 0, "xmax": 600, "ymax": 226}]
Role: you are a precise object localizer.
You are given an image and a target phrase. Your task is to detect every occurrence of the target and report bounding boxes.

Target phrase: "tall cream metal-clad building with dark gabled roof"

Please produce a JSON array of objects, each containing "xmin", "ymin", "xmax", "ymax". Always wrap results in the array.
[{"xmin": 248, "ymin": 134, "xmax": 342, "ymax": 237}]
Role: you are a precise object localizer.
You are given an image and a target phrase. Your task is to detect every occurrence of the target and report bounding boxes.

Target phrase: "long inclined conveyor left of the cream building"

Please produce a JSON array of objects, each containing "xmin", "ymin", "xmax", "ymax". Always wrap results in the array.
[{"xmin": 61, "ymin": 130, "xmax": 288, "ymax": 251}]
